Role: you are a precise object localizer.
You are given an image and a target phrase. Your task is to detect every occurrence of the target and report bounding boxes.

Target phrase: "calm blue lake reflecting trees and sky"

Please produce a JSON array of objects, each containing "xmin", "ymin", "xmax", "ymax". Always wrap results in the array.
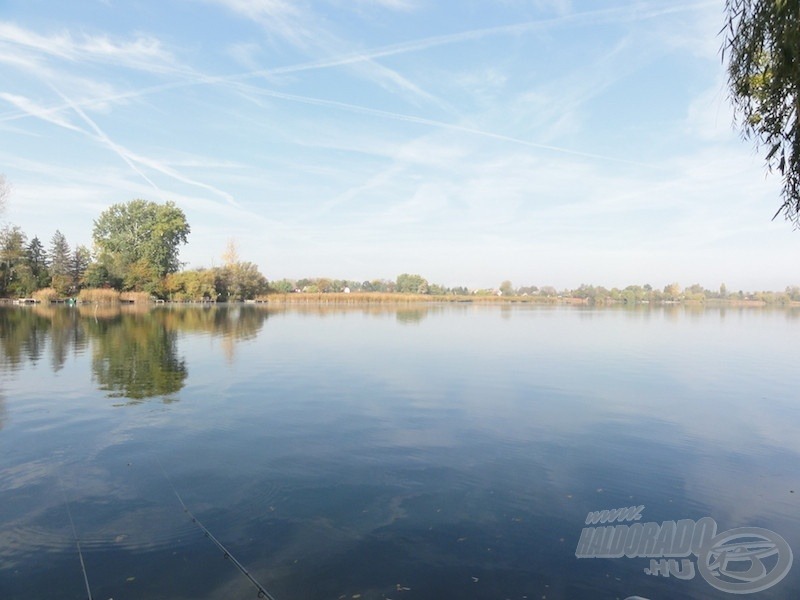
[{"xmin": 0, "ymin": 304, "xmax": 800, "ymax": 600}]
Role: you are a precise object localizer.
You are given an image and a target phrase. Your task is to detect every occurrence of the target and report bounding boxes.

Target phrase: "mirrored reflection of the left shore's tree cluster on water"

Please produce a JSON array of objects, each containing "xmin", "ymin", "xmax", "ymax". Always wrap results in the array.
[{"xmin": 0, "ymin": 305, "xmax": 269, "ymax": 404}]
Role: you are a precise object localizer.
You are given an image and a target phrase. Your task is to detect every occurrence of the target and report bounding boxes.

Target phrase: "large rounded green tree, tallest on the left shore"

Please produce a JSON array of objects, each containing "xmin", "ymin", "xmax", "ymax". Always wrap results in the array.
[{"xmin": 92, "ymin": 200, "xmax": 190, "ymax": 291}]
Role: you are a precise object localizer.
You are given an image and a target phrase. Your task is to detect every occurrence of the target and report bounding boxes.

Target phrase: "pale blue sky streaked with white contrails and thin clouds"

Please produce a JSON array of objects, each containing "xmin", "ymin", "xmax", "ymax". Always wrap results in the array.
[{"xmin": 0, "ymin": 0, "xmax": 800, "ymax": 290}]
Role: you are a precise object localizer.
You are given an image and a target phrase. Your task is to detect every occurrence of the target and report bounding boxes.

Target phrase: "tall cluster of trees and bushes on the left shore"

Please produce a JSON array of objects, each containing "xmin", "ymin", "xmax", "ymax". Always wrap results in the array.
[{"xmin": 0, "ymin": 200, "xmax": 268, "ymax": 301}]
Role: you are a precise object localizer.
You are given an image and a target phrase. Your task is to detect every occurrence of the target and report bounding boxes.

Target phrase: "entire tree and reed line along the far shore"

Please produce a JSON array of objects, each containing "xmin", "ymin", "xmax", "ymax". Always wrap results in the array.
[{"xmin": 0, "ymin": 193, "xmax": 800, "ymax": 304}]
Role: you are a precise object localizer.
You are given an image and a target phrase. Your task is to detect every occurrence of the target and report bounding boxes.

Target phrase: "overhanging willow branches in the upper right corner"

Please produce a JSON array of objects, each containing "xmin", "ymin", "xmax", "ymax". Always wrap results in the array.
[{"xmin": 722, "ymin": 0, "xmax": 800, "ymax": 224}]
